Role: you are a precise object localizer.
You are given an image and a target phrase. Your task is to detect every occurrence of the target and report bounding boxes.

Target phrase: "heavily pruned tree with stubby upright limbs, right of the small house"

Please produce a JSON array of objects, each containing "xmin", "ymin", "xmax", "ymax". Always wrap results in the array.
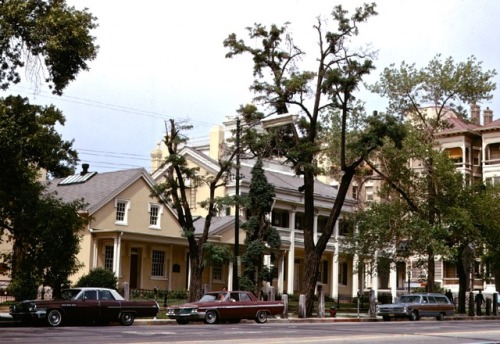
[{"xmin": 155, "ymin": 120, "xmax": 236, "ymax": 301}]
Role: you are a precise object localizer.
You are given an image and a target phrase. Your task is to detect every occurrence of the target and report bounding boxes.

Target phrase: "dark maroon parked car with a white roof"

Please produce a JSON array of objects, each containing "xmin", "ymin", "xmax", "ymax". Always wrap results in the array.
[{"xmin": 10, "ymin": 288, "xmax": 160, "ymax": 326}]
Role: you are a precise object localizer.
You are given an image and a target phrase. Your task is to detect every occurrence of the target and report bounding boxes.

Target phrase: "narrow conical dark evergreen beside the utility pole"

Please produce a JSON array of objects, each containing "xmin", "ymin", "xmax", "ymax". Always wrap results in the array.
[{"xmin": 240, "ymin": 159, "xmax": 281, "ymax": 295}]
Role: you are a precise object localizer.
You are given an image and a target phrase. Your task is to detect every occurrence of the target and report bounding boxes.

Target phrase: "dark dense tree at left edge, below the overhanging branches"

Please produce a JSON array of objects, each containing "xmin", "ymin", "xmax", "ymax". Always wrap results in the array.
[{"xmin": 0, "ymin": 97, "xmax": 80, "ymax": 297}]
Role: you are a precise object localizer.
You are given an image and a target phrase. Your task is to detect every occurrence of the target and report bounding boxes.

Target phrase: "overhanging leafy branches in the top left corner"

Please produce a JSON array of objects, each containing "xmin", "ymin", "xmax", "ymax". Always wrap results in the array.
[{"xmin": 0, "ymin": 0, "xmax": 98, "ymax": 95}]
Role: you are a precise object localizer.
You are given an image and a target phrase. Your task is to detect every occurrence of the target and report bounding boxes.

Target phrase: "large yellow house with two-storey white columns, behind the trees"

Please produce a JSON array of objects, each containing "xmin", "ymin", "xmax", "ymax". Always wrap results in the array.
[{"xmin": 151, "ymin": 121, "xmax": 359, "ymax": 297}]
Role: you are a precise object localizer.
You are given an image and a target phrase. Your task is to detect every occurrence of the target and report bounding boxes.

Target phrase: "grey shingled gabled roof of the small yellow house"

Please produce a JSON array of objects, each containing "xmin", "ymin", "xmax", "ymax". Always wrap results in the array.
[{"xmin": 47, "ymin": 168, "xmax": 159, "ymax": 215}]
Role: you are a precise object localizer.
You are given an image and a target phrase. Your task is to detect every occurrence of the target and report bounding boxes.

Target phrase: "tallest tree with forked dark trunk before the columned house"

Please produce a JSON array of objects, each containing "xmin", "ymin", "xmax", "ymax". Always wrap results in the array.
[{"xmin": 224, "ymin": 4, "xmax": 401, "ymax": 316}]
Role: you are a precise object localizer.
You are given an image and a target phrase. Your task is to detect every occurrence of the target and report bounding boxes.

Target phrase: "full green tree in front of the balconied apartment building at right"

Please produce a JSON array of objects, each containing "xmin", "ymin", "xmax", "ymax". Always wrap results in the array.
[{"xmin": 364, "ymin": 55, "xmax": 496, "ymax": 291}]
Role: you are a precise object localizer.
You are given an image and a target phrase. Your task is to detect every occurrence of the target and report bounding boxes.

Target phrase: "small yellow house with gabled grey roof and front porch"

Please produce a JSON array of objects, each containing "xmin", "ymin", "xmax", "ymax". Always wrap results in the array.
[{"xmin": 42, "ymin": 164, "xmax": 187, "ymax": 289}]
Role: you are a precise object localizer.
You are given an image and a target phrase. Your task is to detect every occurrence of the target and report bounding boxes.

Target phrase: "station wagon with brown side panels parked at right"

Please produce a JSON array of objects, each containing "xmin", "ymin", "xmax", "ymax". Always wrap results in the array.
[{"xmin": 377, "ymin": 293, "xmax": 455, "ymax": 321}]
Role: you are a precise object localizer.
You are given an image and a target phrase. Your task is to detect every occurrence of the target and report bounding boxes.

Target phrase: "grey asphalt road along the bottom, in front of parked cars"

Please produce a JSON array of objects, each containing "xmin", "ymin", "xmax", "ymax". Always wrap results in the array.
[{"xmin": 0, "ymin": 320, "xmax": 500, "ymax": 344}]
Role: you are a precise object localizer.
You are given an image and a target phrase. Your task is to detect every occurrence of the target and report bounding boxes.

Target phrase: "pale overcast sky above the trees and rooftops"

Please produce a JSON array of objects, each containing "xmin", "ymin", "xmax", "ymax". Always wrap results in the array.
[{"xmin": 5, "ymin": 0, "xmax": 500, "ymax": 172}]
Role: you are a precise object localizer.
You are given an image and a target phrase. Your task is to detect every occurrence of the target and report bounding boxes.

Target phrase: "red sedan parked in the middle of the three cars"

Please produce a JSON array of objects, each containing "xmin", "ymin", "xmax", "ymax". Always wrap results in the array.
[{"xmin": 167, "ymin": 291, "xmax": 284, "ymax": 324}]
